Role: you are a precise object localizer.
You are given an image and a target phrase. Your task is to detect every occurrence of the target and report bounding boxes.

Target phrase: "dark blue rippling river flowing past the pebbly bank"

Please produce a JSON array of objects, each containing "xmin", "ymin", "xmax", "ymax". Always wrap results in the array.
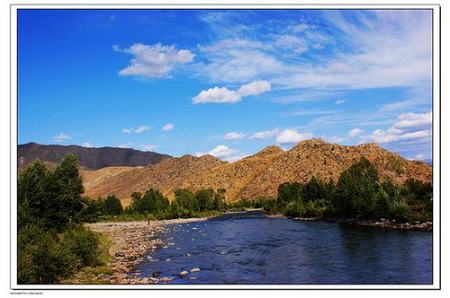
[{"xmin": 134, "ymin": 213, "xmax": 432, "ymax": 284}]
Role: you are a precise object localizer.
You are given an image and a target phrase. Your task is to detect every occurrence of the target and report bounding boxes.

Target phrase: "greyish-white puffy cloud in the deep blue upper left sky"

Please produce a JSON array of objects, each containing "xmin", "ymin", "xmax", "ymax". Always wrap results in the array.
[{"xmin": 113, "ymin": 43, "xmax": 194, "ymax": 78}]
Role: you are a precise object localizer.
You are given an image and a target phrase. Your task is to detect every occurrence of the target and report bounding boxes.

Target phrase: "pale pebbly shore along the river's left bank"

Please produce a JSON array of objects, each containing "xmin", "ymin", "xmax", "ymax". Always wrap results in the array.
[{"xmin": 86, "ymin": 218, "xmax": 208, "ymax": 284}]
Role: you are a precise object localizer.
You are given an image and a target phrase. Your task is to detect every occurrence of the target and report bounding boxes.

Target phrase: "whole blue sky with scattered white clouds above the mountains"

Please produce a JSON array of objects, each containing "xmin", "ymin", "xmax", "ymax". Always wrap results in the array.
[{"xmin": 18, "ymin": 10, "xmax": 432, "ymax": 161}]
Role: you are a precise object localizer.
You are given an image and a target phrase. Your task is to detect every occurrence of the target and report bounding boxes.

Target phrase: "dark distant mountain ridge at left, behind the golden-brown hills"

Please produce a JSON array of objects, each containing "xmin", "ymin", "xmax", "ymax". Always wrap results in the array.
[{"xmin": 17, "ymin": 143, "xmax": 171, "ymax": 170}]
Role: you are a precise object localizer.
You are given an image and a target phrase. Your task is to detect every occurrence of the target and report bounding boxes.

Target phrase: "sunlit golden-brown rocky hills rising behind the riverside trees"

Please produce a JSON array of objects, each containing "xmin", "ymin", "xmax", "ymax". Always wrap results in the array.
[{"xmin": 82, "ymin": 139, "xmax": 432, "ymax": 205}]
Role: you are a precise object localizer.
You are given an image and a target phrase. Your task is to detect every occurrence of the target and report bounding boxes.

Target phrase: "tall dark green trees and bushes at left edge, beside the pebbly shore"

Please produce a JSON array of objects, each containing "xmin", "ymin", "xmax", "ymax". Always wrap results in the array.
[{"xmin": 17, "ymin": 155, "xmax": 103, "ymax": 284}]
